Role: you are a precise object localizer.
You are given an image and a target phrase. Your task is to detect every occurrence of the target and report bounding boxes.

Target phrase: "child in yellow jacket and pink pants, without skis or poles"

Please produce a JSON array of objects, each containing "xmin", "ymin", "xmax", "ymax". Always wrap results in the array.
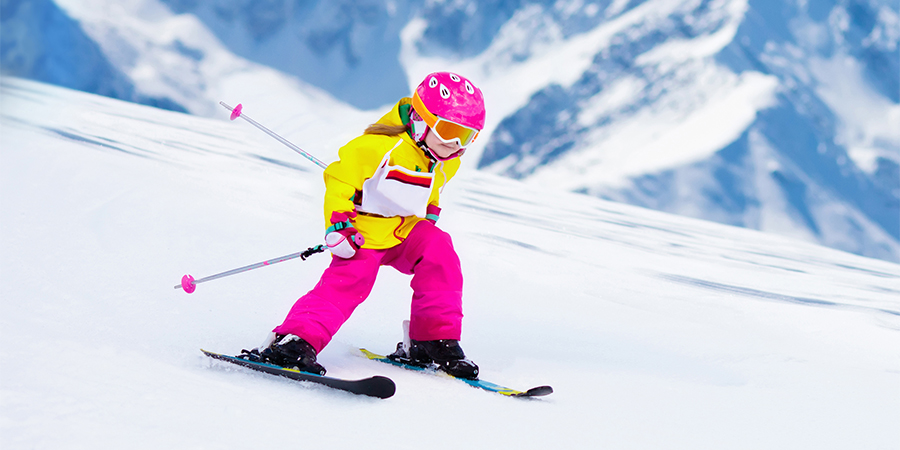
[{"xmin": 245, "ymin": 72, "xmax": 485, "ymax": 379}]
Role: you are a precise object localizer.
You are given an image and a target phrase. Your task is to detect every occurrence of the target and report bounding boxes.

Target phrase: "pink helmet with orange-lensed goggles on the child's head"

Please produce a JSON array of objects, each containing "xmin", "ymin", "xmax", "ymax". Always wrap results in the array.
[{"xmin": 412, "ymin": 72, "xmax": 484, "ymax": 148}]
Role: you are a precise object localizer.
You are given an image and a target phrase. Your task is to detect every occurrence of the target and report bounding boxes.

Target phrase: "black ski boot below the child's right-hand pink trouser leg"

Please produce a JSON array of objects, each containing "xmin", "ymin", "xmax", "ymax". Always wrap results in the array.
[{"xmin": 388, "ymin": 339, "xmax": 478, "ymax": 380}]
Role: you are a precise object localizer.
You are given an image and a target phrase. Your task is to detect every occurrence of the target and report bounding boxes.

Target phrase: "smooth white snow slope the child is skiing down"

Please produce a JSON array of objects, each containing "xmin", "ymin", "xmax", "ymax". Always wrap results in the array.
[{"xmin": 0, "ymin": 77, "xmax": 900, "ymax": 449}]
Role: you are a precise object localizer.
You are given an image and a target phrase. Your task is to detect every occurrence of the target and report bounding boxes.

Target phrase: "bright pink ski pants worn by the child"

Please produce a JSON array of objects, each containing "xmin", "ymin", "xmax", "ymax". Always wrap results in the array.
[{"xmin": 274, "ymin": 220, "xmax": 463, "ymax": 352}]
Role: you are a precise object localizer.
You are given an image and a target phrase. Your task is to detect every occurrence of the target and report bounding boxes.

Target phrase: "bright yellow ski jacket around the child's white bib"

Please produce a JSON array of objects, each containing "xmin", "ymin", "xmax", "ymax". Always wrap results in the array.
[{"xmin": 324, "ymin": 97, "xmax": 460, "ymax": 249}]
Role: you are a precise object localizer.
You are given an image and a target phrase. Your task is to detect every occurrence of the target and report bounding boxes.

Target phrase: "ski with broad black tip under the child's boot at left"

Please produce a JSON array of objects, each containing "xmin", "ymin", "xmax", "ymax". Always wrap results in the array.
[{"xmin": 207, "ymin": 349, "xmax": 397, "ymax": 398}]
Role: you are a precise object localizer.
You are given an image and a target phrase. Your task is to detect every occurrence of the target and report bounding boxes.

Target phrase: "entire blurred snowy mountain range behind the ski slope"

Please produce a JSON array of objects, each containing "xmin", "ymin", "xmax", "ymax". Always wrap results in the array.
[{"xmin": 0, "ymin": 0, "xmax": 900, "ymax": 261}]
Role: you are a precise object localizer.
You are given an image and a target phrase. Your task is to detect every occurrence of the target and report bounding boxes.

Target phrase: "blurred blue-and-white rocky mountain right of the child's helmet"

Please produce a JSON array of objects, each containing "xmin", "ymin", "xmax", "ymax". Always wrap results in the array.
[{"xmin": 480, "ymin": 1, "xmax": 900, "ymax": 261}]
